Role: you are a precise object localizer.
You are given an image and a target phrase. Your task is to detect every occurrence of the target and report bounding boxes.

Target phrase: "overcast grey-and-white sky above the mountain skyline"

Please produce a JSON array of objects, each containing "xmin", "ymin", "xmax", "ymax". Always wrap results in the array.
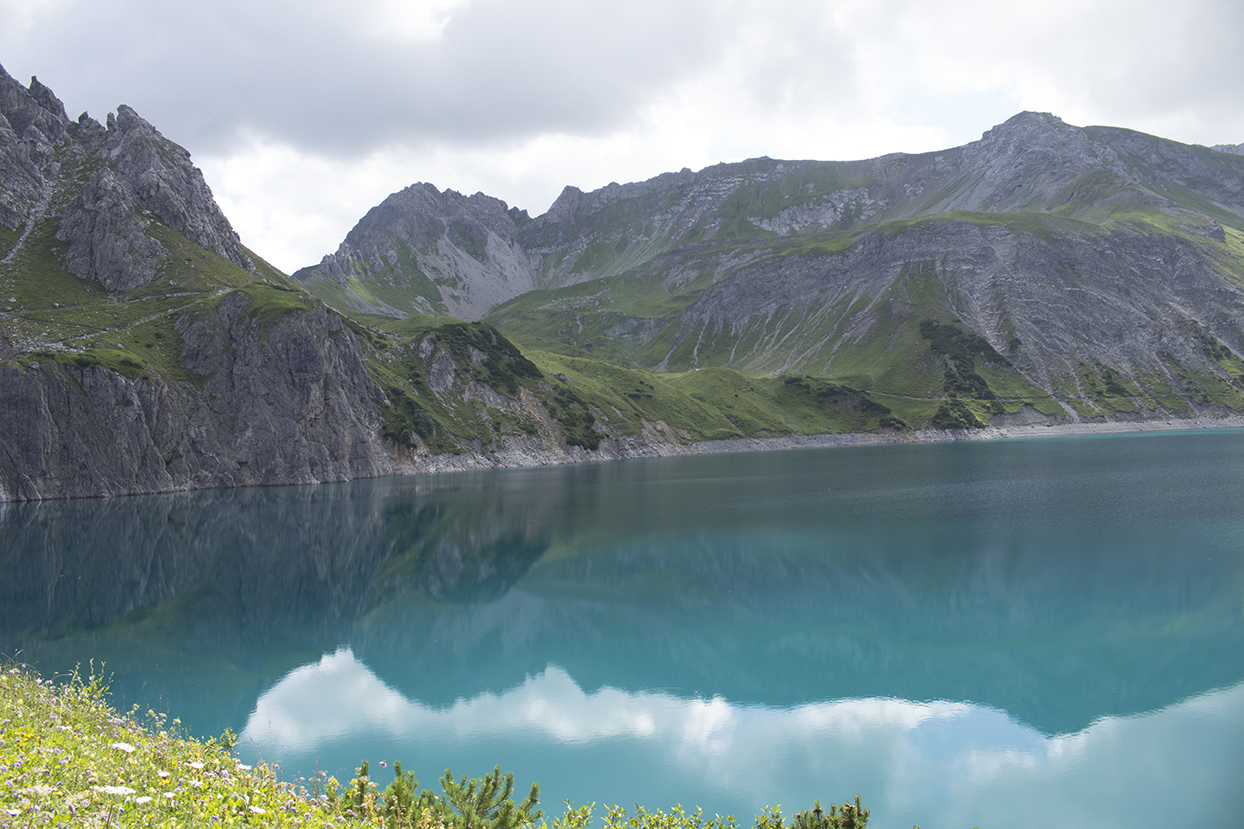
[{"xmin": 0, "ymin": 0, "xmax": 1244, "ymax": 271}]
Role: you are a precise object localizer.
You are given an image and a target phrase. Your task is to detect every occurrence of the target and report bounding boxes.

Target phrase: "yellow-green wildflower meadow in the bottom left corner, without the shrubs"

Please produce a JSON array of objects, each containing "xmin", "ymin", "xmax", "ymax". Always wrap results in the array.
[{"xmin": 0, "ymin": 666, "xmax": 363, "ymax": 829}]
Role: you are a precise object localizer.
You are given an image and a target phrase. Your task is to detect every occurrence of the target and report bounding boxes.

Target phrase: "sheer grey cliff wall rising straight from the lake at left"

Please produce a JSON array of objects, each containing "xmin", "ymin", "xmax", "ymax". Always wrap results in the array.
[{"xmin": 0, "ymin": 294, "xmax": 391, "ymax": 502}]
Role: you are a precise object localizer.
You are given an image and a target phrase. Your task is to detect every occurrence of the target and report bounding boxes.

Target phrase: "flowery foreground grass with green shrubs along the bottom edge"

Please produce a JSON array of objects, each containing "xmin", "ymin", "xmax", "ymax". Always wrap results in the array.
[{"xmin": 0, "ymin": 666, "xmax": 868, "ymax": 829}]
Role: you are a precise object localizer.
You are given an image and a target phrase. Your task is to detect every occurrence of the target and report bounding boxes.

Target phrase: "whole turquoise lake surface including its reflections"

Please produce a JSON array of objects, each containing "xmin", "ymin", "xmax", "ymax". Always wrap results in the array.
[{"xmin": 0, "ymin": 431, "xmax": 1244, "ymax": 829}]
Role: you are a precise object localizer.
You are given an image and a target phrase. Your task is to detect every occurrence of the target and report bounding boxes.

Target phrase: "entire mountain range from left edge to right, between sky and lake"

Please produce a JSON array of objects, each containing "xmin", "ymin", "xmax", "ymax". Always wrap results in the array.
[{"xmin": 0, "ymin": 61, "xmax": 1244, "ymax": 502}]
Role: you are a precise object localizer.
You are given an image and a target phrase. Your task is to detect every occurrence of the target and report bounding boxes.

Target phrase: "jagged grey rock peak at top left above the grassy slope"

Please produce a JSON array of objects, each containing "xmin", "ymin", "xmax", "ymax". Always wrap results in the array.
[{"xmin": 0, "ymin": 67, "xmax": 255, "ymax": 291}]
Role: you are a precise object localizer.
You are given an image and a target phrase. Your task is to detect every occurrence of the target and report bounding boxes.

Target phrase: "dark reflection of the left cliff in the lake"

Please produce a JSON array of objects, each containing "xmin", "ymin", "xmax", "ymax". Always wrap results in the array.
[{"xmin": 0, "ymin": 478, "xmax": 547, "ymax": 736}]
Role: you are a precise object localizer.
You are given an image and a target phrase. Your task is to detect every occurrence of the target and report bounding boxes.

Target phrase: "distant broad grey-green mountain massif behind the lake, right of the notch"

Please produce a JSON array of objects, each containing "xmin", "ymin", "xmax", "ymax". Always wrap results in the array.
[{"xmin": 295, "ymin": 112, "xmax": 1244, "ymax": 426}]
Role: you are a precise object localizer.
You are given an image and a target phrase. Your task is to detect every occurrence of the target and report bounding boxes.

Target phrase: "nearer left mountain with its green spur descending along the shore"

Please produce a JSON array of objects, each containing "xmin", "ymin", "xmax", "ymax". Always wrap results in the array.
[{"xmin": 0, "ymin": 68, "xmax": 796, "ymax": 503}]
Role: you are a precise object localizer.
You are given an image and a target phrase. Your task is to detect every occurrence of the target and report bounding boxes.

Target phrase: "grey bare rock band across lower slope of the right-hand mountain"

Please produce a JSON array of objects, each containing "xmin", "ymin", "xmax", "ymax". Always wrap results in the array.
[{"xmin": 648, "ymin": 222, "xmax": 1244, "ymax": 375}]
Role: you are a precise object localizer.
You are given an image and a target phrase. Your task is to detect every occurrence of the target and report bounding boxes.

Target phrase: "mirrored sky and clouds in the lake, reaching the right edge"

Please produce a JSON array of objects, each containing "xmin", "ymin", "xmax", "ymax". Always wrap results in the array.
[{"xmin": 241, "ymin": 651, "xmax": 1244, "ymax": 829}]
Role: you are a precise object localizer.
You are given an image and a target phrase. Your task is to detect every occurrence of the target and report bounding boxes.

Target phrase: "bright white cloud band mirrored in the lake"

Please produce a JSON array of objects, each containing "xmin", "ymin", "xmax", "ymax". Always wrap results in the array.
[{"xmin": 241, "ymin": 649, "xmax": 972, "ymax": 757}]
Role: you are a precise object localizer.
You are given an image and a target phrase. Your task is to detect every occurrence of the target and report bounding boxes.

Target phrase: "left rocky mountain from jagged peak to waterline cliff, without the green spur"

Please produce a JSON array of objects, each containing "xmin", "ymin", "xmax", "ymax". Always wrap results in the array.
[{"xmin": 0, "ymin": 70, "xmax": 403, "ymax": 500}]
